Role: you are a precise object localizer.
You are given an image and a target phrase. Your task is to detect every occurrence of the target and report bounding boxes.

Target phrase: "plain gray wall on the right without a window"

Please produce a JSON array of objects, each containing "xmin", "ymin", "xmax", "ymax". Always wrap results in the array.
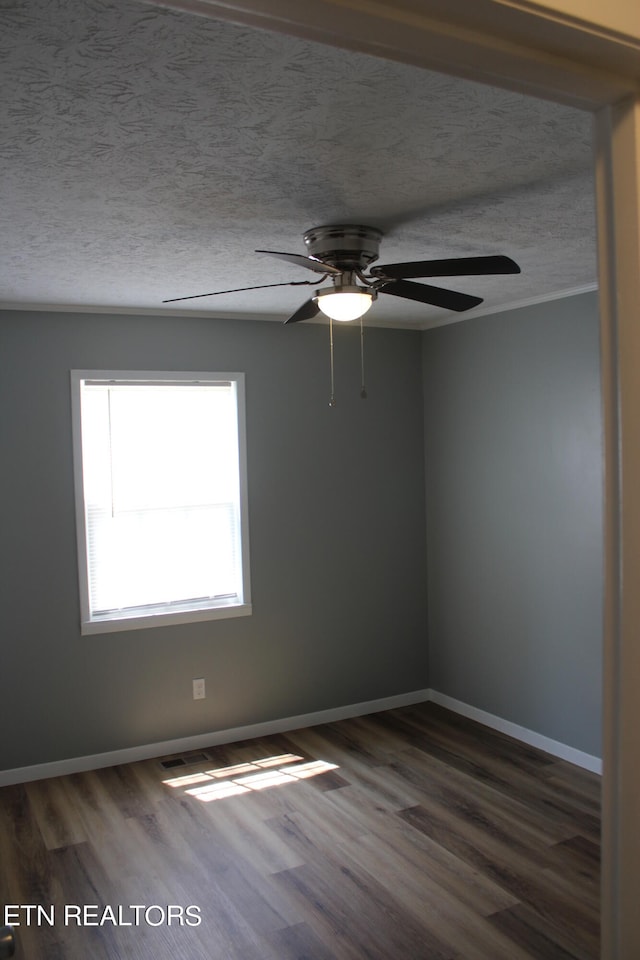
[{"xmin": 423, "ymin": 294, "xmax": 602, "ymax": 756}]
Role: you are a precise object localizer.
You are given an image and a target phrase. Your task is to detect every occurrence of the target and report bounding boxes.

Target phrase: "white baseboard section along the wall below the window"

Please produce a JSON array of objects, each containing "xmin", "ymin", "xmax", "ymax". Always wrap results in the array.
[{"xmin": 0, "ymin": 690, "xmax": 429, "ymax": 787}]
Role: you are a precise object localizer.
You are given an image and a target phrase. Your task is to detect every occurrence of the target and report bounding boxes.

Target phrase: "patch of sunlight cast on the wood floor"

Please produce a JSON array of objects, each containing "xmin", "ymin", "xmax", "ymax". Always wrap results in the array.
[{"xmin": 163, "ymin": 753, "xmax": 337, "ymax": 803}]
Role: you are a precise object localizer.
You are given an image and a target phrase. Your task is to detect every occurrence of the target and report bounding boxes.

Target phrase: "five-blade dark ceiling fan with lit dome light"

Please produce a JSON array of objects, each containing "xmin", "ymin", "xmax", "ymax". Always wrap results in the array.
[{"xmin": 162, "ymin": 224, "xmax": 520, "ymax": 323}]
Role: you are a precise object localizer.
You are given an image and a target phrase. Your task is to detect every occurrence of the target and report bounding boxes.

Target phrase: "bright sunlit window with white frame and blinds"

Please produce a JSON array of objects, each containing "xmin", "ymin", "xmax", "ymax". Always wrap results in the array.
[{"xmin": 71, "ymin": 370, "xmax": 251, "ymax": 634}]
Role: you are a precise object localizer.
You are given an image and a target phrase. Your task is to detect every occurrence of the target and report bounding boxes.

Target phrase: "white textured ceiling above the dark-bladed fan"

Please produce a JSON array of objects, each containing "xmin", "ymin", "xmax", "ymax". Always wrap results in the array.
[{"xmin": 0, "ymin": 0, "xmax": 596, "ymax": 327}]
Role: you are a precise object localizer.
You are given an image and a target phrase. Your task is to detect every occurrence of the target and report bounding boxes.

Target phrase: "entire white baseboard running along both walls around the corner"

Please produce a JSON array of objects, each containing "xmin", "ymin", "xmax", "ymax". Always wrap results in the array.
[{"xmin": 0, "ymin": 689, "xmax": 602, "ymax": 787}]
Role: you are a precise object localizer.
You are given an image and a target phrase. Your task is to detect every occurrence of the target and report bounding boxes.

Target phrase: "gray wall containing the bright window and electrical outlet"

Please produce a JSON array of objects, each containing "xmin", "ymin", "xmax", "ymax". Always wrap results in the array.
[{"xmin": 0, "ymin": 312, "xmax": 428, "ymax": 769}]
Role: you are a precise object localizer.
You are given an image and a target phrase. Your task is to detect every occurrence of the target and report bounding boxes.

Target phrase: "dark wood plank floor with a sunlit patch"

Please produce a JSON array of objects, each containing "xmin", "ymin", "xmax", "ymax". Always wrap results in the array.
[{"xmin": 0, "ymin": 704, "xmax": 600, "ymax": 960}]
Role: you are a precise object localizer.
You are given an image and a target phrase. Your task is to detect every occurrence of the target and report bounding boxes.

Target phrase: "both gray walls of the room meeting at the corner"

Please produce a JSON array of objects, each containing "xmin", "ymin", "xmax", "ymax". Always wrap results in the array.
[{"xmin": 0, "ymin": 295, "xmax": 602, "ymax": 769}]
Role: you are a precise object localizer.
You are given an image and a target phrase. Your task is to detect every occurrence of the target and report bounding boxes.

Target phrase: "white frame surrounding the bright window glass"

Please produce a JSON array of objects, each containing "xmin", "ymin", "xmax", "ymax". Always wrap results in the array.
[{"xmin": 70, "ymin": 370, "xmax": 252, "ymax": 636}]
